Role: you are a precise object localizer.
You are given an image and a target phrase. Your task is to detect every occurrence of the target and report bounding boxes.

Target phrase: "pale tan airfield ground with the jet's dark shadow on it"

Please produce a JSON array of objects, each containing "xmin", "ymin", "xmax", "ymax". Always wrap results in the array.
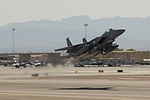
[{"xmin": 0, "ymin": 65, "xmax": 150, "ymax": 100}]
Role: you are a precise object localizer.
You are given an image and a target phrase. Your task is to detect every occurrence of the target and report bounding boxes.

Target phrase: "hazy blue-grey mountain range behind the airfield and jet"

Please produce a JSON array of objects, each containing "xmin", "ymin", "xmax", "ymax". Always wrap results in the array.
[{"xmin": 0, "ymin": 16, "xmax": 150, "ymax": 52}]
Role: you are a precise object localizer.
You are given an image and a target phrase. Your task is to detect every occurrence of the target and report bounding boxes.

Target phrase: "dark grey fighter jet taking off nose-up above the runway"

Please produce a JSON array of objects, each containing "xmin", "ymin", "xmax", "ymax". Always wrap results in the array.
[{"xmin": 55, "ymin": 29, "xmax": 125, "ymax": 58}]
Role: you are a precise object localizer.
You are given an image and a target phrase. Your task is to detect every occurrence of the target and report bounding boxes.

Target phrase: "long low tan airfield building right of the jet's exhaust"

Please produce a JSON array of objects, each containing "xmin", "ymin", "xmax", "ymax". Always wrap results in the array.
[{"xmin": 101, "ymin": 51, "xmax": 150, "ymax": 64}]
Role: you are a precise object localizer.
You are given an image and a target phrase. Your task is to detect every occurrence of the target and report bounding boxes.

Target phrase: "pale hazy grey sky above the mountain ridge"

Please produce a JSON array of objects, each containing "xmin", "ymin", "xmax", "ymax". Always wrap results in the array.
[{"xmin": 0, "ymin": 0, "xmax": 150, "ymax": 26}]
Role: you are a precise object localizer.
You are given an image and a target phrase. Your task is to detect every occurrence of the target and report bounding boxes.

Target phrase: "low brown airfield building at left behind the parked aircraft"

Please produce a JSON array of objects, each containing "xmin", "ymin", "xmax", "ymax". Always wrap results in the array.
[{"xmin": 0, "ymin": 53, "xmax": 62, "ymax": 65}]
